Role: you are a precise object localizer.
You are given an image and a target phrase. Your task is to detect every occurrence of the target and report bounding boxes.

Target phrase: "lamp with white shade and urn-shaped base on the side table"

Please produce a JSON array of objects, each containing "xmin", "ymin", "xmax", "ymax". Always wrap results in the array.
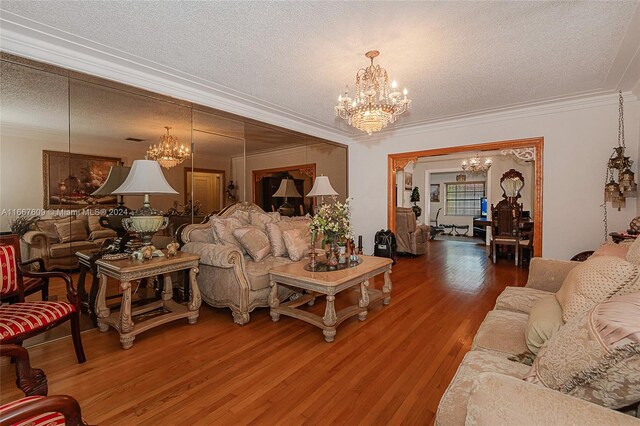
[{"xmin": 112, "ymin": 160, "xmax": 178, "ymax": 246}]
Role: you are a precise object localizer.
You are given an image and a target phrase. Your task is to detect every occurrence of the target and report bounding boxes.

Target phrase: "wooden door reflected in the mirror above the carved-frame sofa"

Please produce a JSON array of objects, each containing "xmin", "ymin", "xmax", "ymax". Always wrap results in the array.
[{"xmin": 184, "ymin": 168, "xmax": 225, "ymax": 213}]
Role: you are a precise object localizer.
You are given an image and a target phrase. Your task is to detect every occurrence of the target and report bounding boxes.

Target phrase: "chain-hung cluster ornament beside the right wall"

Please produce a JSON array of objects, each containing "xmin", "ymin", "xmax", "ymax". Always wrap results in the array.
[{"xmin": 604, "ymin": 91, "xmax": 638, "ymax": 210}]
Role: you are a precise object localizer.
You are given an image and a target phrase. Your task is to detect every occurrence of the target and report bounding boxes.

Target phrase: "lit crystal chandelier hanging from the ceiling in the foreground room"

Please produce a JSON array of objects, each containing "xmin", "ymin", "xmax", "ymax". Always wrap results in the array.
[{"xmin": 335, "ymin": 50, "xmax": 411, "ymax": 135}]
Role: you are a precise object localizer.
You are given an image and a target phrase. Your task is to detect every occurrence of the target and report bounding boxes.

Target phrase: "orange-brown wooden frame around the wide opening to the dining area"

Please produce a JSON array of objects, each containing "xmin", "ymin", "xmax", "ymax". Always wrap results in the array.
[{"xmin": 387, "ymin": 137, "xmax": 544, "ymax": 256}]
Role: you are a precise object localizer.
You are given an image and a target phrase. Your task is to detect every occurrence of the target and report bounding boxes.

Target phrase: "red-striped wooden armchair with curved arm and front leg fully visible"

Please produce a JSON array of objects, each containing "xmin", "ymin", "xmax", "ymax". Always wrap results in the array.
[{"xmin": 0, "ymin": 235, "xmax": 86, "ymax": 363}]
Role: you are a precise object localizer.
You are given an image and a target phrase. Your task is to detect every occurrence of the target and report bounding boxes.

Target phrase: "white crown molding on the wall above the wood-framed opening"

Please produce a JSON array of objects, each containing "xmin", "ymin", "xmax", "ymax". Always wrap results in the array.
[{"xmin": 352, "ymin": 91, "xmax": 638, "ymax": 143}]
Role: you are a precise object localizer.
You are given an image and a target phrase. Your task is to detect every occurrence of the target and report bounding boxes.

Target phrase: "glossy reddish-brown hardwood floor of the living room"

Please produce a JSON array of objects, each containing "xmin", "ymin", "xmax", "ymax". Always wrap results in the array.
[{"xmin": 0, "ymin": 241, "xmax": 527, "ymax": 425}]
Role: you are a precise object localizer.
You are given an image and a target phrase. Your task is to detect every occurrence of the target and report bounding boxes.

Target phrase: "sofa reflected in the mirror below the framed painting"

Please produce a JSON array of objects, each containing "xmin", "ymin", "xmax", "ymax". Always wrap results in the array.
[{"xmin": 22, "ymin": 210, "xmax": 116, "ymax": 270}]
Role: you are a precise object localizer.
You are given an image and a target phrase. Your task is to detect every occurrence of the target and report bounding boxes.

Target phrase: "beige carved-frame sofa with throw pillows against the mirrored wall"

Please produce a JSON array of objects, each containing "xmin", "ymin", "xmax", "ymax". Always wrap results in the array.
[{"xmin": 180, "ymin": 203, "xmax": 310, "ymax": 325}]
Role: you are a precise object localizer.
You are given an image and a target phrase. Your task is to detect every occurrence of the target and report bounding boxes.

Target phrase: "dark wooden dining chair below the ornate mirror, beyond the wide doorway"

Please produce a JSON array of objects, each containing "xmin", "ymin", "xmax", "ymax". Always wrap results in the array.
[{"xmin": 491, "ymin": 198, "xmax": 522, "ymax": 266}]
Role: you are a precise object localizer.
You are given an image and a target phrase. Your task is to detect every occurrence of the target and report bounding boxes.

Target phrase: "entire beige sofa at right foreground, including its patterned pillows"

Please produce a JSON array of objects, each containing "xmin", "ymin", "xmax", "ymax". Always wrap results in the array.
[{"xmin": 436, "ymin": 255, "xmax": 640, "ymax": 426}]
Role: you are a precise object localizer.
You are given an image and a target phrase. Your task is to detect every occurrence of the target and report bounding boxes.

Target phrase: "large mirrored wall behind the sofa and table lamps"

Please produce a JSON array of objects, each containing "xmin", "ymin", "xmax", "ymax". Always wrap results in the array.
[{"xmin": 0, "ymin": 53, "xmax": 347, "ymax": 233}]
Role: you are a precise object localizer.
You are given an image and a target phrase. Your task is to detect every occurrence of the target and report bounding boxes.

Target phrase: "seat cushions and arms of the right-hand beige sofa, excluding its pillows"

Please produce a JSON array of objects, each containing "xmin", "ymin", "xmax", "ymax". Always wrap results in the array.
[{"xmin": 436, "ymin": 258, "xmax": 640, "ymax": 426}]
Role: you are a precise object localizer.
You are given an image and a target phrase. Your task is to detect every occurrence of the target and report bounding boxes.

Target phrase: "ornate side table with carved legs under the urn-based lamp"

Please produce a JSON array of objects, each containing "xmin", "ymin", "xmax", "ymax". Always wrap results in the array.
[{"xmin": 96, "ymin": 250, "xmax": 202, "ymax": 349}]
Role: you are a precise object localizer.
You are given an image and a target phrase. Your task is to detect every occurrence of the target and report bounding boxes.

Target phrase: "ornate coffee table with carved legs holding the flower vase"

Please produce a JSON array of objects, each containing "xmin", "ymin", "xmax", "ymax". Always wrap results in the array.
[{"xmin": 269, "ymin": 256, "xmax": 392, "ymax": 342}]
